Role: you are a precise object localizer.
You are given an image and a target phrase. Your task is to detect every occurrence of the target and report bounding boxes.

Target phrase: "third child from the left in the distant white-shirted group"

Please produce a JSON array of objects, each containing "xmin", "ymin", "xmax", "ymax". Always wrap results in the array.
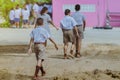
[{"xmin": 22, "ymin": 6, "xmax": 30, "ymax": 28}]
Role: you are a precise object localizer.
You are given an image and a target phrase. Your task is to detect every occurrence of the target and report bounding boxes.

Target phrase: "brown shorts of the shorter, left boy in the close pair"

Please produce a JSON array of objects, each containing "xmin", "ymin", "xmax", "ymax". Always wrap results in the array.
[{"xmin": 63, "ymin": 30, "xmax": 74, "ymax": 44}]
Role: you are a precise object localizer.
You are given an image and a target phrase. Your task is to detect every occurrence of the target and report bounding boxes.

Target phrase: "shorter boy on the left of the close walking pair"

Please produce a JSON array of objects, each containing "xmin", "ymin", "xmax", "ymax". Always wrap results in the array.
[{"xmin": 60, "ymin": 9, "xmax": 78, "ymax": 59}]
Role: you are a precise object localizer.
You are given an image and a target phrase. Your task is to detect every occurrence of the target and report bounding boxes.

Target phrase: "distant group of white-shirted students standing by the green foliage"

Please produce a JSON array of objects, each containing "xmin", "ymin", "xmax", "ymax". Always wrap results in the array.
[{"xmin": 9, "ymin": 2, "xmax": 52, "ymax": 28}]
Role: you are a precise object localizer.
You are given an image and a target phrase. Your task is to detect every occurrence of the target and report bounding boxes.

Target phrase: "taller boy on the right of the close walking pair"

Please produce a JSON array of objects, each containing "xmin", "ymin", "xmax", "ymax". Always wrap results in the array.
[{"xmin": 72, "ymin": 4, "xmax": 86, "ymax": 57}]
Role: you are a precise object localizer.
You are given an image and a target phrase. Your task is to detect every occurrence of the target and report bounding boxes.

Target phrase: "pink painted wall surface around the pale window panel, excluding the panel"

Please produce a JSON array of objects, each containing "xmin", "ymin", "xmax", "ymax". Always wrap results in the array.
[{"xmin": 52, "ymin": 0, "xmax": 120, "ymax": 27}]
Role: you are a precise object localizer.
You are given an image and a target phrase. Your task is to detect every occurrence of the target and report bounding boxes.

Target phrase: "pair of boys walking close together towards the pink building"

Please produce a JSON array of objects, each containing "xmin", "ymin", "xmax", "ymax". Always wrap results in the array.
[{"xmin": 60, "ymin": 4, "xmax": 86, "ymax": 59}]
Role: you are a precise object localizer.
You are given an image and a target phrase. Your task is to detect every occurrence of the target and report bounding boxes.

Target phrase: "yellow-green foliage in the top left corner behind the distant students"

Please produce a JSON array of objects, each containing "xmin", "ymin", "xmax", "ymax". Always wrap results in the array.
[{"xmin": 0, "ymin": 0, "xmax": 51, "ymax": 27}]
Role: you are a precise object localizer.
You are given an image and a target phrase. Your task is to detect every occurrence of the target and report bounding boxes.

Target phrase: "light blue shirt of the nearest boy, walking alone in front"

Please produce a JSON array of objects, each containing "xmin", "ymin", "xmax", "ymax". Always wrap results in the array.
[{"xmin": 30, "ymin": 26, "xmax": 50, "ymax": 43}]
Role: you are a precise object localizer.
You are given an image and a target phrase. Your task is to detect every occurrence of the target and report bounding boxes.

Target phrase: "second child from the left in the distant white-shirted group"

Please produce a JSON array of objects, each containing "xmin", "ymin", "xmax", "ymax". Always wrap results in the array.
[{"xmin": 14, "ymin": 5, "xmax": 21, "ymax": 28}]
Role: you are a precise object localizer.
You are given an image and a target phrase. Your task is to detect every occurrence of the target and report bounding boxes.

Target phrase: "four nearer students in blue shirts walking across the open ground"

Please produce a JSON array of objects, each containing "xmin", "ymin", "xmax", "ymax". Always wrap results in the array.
[{"xmin": 28, "ymin": 4, "xmax": 86, "ymax": 80}]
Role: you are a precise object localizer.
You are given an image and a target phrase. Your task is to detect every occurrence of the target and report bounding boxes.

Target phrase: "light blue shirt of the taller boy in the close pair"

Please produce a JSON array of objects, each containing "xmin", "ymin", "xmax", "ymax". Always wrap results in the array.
[{"xmin": 72, "ymin": 11, "xmax": 85, "ymax": 25}]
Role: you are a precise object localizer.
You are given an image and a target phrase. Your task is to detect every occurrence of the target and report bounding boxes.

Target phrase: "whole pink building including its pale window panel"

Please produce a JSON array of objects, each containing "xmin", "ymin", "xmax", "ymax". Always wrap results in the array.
[{"xmin": 52, "ymin": 0, "xmax": 120, "ymax": 27}]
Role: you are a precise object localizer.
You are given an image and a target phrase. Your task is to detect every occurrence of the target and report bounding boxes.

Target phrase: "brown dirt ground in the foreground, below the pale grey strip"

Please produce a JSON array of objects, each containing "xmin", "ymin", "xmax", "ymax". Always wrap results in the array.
[{"xmin": 0, "ymin": 44, "xmax": 120, "ymax": 80}]
